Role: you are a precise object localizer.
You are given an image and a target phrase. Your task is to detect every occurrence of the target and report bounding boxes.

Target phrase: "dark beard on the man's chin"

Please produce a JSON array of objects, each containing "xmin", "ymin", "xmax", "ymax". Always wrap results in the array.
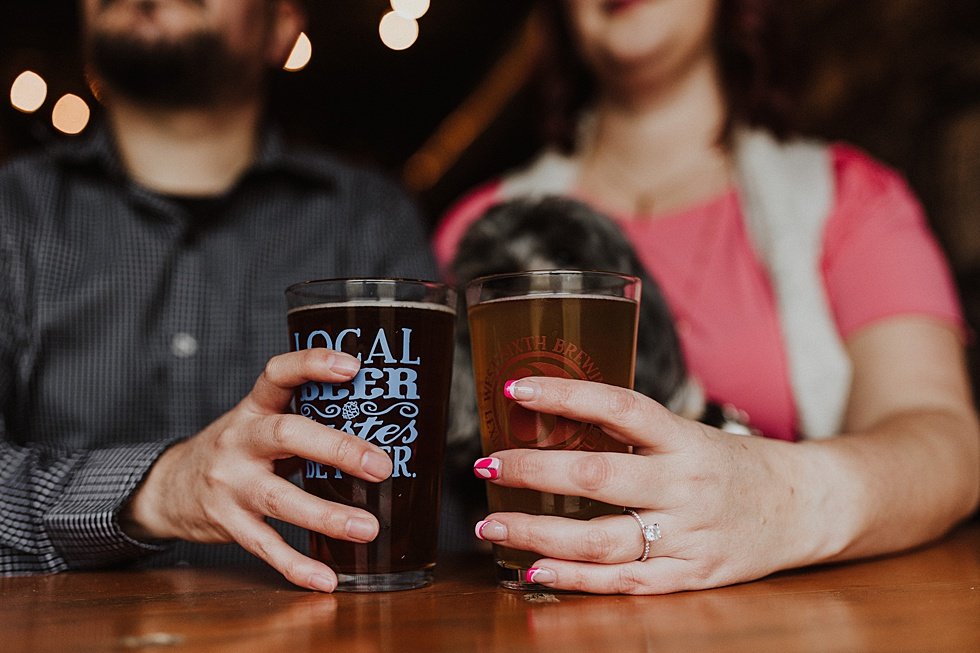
[{"xmin": 88, "ymin": 32, "xmax": 256, "ymax": 109}]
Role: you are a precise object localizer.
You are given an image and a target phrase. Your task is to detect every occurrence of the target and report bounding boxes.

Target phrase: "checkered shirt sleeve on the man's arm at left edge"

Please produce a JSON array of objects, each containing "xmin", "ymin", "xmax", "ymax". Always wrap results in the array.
[{"xmin": 0, "ymin": 211, "xmax": 167, "ymax": 575}]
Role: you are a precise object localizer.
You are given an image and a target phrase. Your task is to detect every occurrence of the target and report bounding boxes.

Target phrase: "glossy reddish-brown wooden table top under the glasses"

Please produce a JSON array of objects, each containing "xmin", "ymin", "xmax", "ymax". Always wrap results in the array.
[{"xmin": 0, "ymin": 520, "xmax": 980, "ymax": 653}]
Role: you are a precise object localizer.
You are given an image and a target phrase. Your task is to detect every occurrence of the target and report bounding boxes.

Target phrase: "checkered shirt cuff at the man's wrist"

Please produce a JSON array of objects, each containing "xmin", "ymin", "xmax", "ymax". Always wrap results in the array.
[{"xmin": 44, "ymin": 441, "xmax": 174, "ymax": 569}]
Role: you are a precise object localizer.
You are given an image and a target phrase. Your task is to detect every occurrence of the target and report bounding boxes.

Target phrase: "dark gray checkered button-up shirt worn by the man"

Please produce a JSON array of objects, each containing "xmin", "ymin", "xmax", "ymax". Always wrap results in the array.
[{"xmin": 0, "ymin": 126, "xmax": 435, "ymax": 573}]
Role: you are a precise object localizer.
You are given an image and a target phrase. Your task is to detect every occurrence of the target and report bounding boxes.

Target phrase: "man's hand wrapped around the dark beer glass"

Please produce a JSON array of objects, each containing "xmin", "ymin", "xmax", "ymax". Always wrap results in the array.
[{"xmin": 122, "ymin": 349, "xmax": 392, "ymax": 592}]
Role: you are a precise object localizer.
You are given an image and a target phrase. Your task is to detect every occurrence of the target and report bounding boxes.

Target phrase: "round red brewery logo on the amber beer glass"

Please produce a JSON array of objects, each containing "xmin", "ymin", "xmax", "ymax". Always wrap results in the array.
[{"xmin": 480, "ymin": 335, "xmax": 603, "ymax": 450}]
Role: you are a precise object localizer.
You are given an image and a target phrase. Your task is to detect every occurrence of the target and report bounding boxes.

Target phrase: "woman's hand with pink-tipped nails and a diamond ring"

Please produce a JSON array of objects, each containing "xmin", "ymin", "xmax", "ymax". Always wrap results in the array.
[{"xmin": 477, "ymin": 377, "xmax": 824, "ymax": 594}]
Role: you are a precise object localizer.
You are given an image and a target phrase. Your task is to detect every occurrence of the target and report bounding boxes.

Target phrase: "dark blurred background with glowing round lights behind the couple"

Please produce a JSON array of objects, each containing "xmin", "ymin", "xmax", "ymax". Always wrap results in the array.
[{"xmin": 0, "ymin": 0, "xmax": 980, "ymax": 398}]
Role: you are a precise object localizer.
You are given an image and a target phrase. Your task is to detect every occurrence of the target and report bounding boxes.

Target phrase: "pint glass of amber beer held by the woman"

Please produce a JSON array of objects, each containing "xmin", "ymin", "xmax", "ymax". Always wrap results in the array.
[{"xmin": 466, "ymin": 270, "xmax": 640, "ymax": 589}]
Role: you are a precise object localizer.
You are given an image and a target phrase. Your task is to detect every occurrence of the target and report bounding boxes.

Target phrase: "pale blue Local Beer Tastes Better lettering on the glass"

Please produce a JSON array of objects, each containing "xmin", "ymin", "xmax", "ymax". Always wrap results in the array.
[{"xmin": 292, "ymin": 327, "xmax": 422, "ymax": 478}]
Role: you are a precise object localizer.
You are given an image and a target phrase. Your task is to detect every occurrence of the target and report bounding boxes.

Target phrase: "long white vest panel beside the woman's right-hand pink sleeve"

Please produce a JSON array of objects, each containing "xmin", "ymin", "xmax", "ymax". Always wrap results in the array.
[{"xmin": 735, "ymin": 130, "xmax": 851, "ymax": 438}]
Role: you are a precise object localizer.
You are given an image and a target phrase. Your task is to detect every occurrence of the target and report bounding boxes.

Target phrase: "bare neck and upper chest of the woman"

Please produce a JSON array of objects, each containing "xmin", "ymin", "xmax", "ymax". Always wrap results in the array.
[{"xmin": 579, "ymin": 57, "xmax": 731, "ymax": 215}]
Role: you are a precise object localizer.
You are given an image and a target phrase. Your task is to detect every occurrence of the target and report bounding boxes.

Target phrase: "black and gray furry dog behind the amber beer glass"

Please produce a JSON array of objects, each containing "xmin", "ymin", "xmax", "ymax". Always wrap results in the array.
[{"xmin": 449, "ymin": 196, "xmax": 687, "ymax": 464}]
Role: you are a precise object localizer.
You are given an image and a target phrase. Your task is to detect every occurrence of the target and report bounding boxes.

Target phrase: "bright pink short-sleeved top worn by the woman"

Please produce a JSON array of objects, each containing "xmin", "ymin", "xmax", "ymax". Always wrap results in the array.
[{"xmin": 434, "ymin": 145, "xmax": 963, "ymax": 440}]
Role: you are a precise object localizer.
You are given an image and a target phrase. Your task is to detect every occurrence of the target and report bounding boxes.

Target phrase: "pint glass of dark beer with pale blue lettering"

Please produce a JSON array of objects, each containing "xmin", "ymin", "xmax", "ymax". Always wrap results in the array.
[{"xmin": 286, "ymin": 279, "xmax": 456, "ymax": 592}]
